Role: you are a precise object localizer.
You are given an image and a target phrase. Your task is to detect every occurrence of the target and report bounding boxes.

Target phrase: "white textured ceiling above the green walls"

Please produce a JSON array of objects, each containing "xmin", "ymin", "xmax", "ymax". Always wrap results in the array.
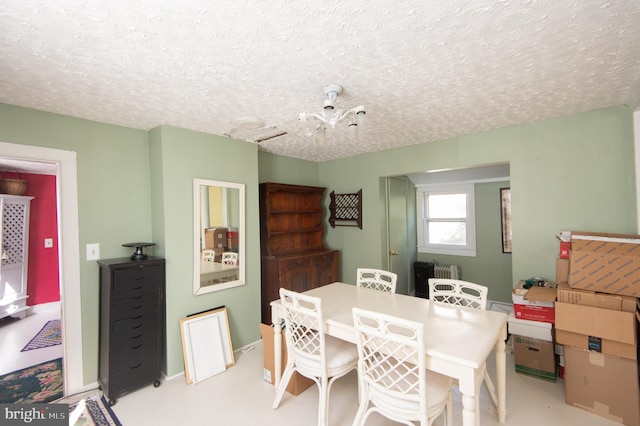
[{"xmin": 0, "ymin": 0, "xmax": 640, "ymax": 161}]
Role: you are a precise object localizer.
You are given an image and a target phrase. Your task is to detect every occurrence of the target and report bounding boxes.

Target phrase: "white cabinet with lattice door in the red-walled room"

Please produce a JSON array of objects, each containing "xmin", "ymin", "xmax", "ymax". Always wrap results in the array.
[{"xmin": 0, "ymin": 194, "xmax": 33, "ymax": 318}]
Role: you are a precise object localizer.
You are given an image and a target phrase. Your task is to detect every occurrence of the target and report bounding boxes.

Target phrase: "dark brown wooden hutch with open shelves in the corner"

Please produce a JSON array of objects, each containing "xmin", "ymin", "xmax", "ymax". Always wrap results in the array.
[{"xmin": 260, "ymin": 182, "xmax": 340, "ymax": 324}]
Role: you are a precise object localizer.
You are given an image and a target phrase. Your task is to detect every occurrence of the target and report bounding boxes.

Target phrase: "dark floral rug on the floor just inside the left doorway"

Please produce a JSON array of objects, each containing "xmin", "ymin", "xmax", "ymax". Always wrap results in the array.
[{"xmin": 0, "ymin": 358, "xmax": 63, "ymax": 404}]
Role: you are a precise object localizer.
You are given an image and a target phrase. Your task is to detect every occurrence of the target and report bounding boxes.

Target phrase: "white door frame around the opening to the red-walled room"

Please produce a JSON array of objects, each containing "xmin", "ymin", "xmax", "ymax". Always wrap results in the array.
[{"xmin": 0, "ymin": 142, "xmax": 85, "ymax": 395}]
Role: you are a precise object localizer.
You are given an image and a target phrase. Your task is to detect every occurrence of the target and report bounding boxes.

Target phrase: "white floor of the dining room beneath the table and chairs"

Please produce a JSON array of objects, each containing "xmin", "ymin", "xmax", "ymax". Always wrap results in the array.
[{"xmin": 112, "ymin": 342, "xmax": 618, "ymax": 426}]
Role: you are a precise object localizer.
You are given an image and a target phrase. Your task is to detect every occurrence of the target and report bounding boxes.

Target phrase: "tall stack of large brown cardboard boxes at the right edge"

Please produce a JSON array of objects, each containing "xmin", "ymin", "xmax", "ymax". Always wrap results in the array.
[{"xmin": 555, "ymin": 231, "xmax": 640, "ymax": 426}]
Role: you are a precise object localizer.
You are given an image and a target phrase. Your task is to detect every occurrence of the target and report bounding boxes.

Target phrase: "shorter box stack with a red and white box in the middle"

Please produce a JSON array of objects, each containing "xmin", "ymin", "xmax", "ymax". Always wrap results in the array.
[{"xmin": 508, "ymin": 281, "xmax": 556, "ymax": 382}]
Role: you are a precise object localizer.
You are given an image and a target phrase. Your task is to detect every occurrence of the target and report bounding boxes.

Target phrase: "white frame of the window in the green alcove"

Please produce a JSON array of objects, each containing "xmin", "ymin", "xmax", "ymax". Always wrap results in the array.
[{"xmin": 416, "ymin": 183, "xmax": 477, "ymax": 257}]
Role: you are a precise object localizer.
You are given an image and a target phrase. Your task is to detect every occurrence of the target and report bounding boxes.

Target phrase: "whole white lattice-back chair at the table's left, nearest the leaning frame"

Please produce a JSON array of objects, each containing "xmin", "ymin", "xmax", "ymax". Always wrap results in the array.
[{"xmin": 273, "ymin": 288, "xmax": 358, "ymax": 426}]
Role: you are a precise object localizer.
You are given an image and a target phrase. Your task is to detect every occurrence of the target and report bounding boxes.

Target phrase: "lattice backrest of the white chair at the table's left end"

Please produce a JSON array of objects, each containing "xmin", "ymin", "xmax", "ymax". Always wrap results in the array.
[{"xmin": 280, "ymin": 288, "xmax": 326, "ymax": 377}]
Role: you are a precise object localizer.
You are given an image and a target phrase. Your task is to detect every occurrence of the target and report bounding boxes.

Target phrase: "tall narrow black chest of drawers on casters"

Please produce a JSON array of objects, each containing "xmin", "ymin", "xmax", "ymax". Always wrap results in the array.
[{"xmin": 98, "ymin": 256, "xmax": 165, "ymax": 405}]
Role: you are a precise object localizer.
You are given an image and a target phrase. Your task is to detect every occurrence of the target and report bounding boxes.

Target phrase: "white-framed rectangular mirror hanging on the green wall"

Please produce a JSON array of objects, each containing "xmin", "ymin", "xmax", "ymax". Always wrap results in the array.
[{"xmin": 193, "ymin": 179, "xmax": 246, "ymax": 295}]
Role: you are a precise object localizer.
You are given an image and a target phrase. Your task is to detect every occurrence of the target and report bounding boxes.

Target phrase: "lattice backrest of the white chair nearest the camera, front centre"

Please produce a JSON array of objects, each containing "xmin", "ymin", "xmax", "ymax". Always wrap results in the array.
[{"xmin": 353, "ymin": 308, "xmax": 428, "ymax": 418}]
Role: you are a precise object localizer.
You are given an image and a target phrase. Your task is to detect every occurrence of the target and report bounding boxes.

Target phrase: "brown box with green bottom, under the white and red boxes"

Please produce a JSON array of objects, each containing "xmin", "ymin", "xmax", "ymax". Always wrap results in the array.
[{"xmin": 512, "ymin": 335, "xmax": 556, "ymax": 382}]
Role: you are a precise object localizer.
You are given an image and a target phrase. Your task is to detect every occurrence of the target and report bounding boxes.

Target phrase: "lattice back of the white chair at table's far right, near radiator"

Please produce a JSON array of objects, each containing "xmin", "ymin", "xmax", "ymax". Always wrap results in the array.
[{"xmin": 429, "ymin": 278, "xmax": 488, "ymax": 309}]
